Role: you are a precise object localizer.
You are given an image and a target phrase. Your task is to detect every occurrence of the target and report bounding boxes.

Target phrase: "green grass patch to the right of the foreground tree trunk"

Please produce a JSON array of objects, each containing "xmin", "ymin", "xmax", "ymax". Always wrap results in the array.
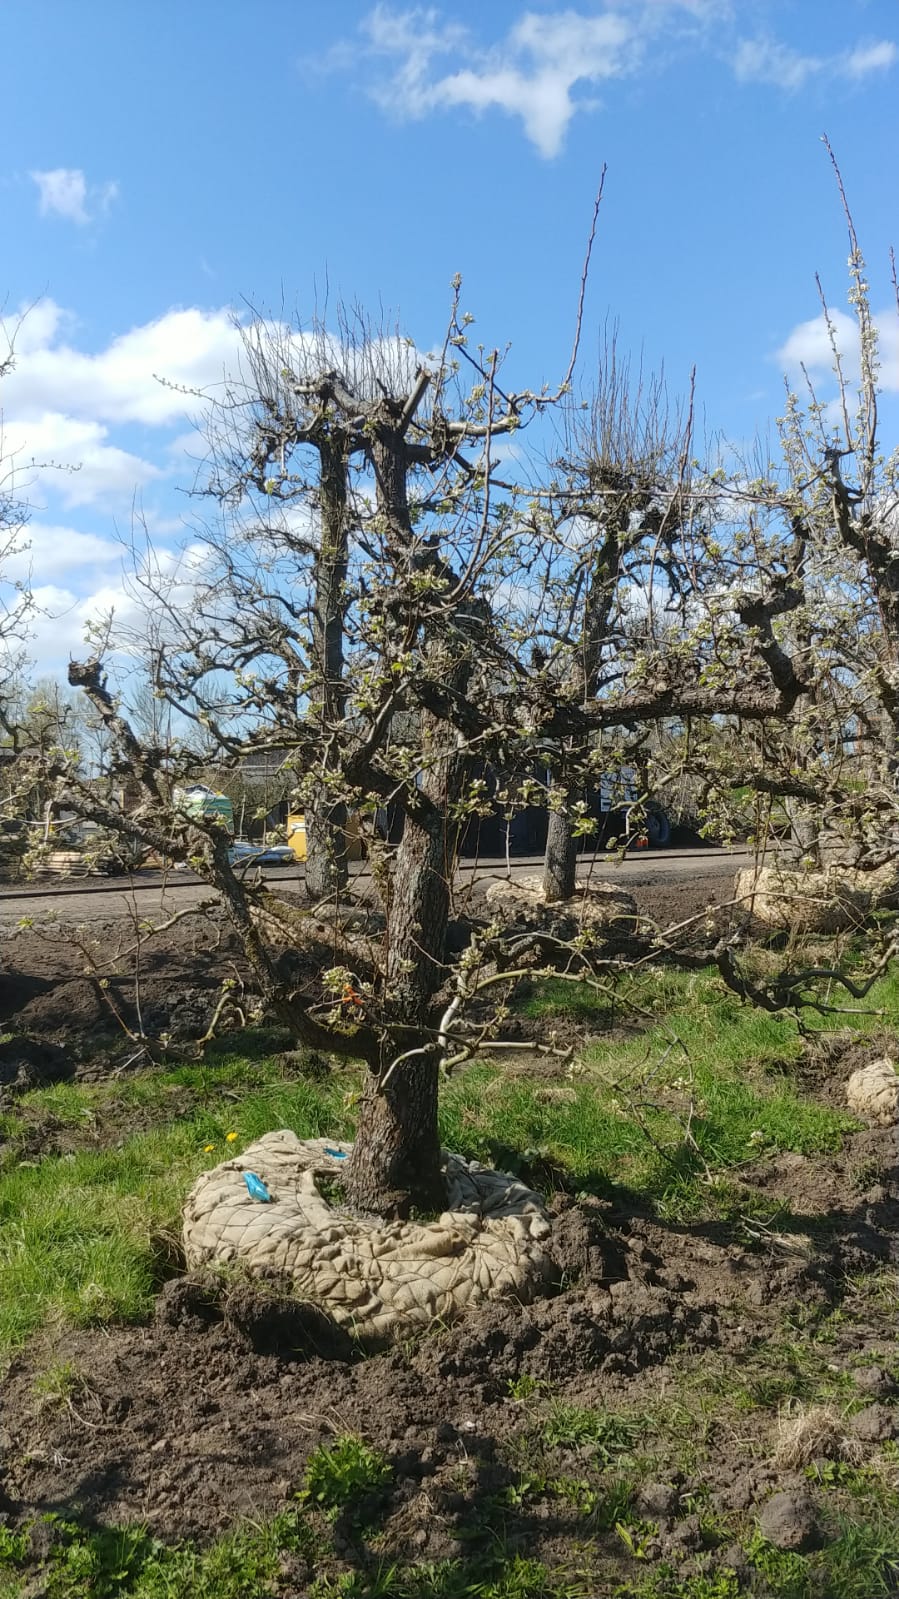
[{"xmin": 443, "ymin": 969, "xmax": 856, "ymax": 1218}]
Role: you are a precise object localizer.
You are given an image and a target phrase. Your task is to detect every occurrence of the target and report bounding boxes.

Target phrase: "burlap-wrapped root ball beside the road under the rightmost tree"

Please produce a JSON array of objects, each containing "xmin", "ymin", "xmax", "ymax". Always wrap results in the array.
[{"xmin": 734, "ymin": 865, "xmax": 899, "ymax": 932}]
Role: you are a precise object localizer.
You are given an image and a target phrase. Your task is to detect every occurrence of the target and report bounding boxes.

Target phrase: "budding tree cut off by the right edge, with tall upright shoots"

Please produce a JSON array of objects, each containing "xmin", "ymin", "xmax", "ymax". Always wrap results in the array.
[{"xmin": 691, "ymin": 147, "xmax": 899, "ymax": 871}]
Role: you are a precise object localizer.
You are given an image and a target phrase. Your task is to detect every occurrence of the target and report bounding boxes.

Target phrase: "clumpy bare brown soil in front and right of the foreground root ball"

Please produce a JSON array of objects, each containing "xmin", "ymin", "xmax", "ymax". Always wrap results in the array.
[{"xmin": 0, "ymin": 1130, "xmax": 899, "ymax": 1570}]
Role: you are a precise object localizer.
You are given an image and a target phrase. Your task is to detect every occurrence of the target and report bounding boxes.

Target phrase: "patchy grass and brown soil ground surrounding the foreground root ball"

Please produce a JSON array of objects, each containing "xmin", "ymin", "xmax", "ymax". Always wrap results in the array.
[{"xmin": 0, "ymin": 884, "xmax": 899, "ymax": 1599}]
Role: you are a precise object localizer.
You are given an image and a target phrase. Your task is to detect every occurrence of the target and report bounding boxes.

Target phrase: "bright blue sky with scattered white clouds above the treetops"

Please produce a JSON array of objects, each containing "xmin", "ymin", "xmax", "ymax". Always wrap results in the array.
[{"xmin": 0, "ymin": 0, "xmax": 899, "ymax": 670}]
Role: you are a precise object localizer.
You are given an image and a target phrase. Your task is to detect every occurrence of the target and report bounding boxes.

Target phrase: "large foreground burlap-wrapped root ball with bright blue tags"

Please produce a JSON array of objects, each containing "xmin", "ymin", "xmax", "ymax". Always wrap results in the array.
[{"xmin": 184, "ymin": 1130, "xmax": 558, "ymax": 1343}]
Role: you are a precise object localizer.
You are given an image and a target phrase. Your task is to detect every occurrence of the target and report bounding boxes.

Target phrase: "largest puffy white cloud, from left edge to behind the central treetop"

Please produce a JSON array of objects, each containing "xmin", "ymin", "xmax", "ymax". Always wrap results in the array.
[{"xmin": 0, "ymin": 299, "xmax": 427, "ymax": 520}]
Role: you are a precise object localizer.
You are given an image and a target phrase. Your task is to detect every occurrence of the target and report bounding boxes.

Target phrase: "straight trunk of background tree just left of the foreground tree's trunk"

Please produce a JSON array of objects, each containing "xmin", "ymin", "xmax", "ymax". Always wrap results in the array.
[{"xmin": 306, "ymin": 433, "xmax": 349, "ymax": 900}]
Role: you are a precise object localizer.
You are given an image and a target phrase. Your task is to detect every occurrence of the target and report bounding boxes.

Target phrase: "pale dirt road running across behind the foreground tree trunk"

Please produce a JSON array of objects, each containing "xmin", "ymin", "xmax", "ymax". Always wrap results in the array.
[{"xmin": 0, "ymin": 849, "xmax": 752, "ymax": 927}]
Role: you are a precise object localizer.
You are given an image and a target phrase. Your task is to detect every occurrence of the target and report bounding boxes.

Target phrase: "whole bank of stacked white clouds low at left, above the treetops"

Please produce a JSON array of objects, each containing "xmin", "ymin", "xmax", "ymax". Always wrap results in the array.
[{"xmin": 0, "ymin": 299, "xmax": 441, "ymax": 673}]
